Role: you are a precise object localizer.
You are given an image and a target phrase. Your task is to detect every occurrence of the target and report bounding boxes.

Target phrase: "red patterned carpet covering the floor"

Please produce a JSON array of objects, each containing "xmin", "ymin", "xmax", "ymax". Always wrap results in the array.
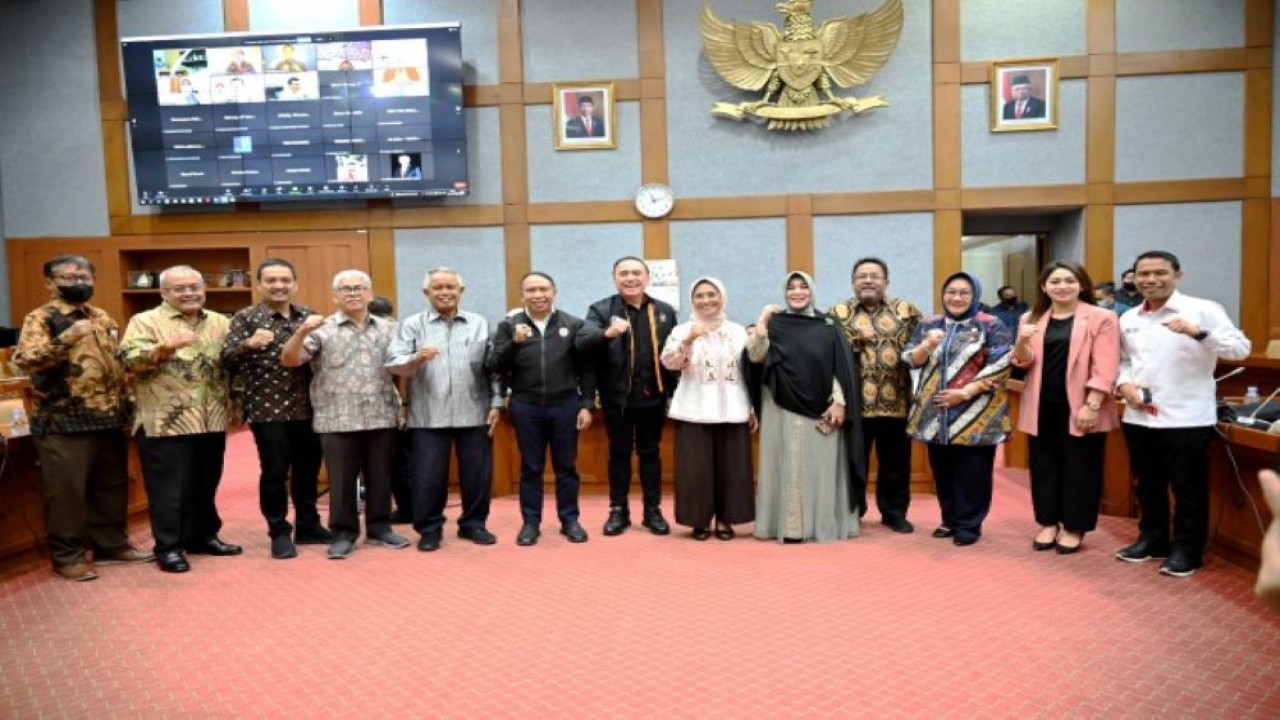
[{"xmin": 0, "ymin": 434, "xmax": 1280, "ymax": 719}]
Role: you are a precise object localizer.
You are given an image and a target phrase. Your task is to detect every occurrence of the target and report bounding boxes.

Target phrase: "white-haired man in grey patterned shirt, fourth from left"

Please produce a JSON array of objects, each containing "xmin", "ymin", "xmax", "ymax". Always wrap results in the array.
[{"xmin": 280, "ymin": 270, "xmax": 408, "ymax": 560}]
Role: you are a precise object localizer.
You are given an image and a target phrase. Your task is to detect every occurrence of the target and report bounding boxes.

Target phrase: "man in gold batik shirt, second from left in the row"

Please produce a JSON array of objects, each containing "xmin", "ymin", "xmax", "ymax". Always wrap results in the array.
[{"xmin": 120, "ymin": 265, "xmax": 242, "ymax": 573}]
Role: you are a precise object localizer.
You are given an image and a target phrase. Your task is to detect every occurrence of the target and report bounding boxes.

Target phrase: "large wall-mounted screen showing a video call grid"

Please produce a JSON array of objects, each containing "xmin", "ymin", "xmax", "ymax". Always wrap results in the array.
[{"xmin": 120, "ymin": 23, "xmax": 468, "ymax": 205}]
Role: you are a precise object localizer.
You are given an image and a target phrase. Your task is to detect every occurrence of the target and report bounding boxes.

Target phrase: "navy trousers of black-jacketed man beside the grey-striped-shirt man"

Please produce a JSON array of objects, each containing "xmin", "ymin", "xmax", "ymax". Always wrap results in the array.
[{"xmin": 509, "ymin": 397, "xmax": 581, "ymax": 525}]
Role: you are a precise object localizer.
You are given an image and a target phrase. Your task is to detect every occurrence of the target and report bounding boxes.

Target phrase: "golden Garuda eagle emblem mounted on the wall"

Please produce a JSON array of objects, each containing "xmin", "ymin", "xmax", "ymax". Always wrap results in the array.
[{"xmin": 703, "ymin": 0, "xmax": 902, "ymax": 131}]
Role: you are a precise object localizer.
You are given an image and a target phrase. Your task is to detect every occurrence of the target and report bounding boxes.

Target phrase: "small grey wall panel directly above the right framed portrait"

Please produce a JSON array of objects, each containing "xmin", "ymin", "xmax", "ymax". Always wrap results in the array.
[{"xmin": 960, "ymin": 0, "xmax": 1087, "ymax": 60}]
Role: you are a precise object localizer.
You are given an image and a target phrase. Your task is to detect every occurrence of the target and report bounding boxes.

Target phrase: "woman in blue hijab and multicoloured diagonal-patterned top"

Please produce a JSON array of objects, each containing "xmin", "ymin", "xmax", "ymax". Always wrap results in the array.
[{"xmin": 902, "ymin": 273, "xmax": 1012, "ymax": 546}]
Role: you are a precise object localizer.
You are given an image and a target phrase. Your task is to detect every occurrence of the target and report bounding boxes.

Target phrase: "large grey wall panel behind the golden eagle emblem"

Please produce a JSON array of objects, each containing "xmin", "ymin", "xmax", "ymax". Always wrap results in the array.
[{"xmin": 663, "ymin": 0, "xmax": 933, "ymax": 196}]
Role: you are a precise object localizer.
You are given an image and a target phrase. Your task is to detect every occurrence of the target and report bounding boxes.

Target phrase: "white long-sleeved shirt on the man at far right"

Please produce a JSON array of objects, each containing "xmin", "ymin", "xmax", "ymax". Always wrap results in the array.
[{"xmin": 1116, "ymin": 291, "xmax": 1252, "ymax": 428}]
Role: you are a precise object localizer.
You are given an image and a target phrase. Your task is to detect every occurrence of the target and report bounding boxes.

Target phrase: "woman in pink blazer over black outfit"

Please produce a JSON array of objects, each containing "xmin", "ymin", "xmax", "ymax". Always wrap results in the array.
[{"xmin": 1011, "ymin": 263, "xmax": 1120, "ymax": 555}]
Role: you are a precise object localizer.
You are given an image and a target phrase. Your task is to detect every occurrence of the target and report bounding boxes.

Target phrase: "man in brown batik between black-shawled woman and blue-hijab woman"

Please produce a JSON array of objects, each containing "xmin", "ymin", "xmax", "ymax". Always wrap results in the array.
[{"xmin": 831, "ymin": 258, "xmax": 920, "ymax": 533}]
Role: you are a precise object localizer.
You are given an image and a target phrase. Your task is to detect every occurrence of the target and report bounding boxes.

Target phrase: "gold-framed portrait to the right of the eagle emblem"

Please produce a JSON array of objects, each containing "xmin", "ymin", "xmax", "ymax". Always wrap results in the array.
[{"xmin": 989, "ymin": 58, "xmax": 1059, "ymax": 132}]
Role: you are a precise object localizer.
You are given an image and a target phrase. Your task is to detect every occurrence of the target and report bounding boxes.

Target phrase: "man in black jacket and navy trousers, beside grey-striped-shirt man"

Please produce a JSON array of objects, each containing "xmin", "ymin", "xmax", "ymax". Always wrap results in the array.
[{"xmin": 490, "ymin": 270, "xmax": 595, "ymax": 547}]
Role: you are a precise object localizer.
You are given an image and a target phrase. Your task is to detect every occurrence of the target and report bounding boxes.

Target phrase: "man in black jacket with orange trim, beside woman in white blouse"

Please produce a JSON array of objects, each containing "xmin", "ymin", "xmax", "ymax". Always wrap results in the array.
[{"xmin": 582, "ymin": 256, "xmax": 677, "ymax": 536}]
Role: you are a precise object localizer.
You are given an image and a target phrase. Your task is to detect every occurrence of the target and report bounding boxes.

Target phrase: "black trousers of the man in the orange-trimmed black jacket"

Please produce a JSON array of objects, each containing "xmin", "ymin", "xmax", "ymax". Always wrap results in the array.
[{"xmin": 604, "ymin": 405, "xmax": 667, "ymax": 510}]
